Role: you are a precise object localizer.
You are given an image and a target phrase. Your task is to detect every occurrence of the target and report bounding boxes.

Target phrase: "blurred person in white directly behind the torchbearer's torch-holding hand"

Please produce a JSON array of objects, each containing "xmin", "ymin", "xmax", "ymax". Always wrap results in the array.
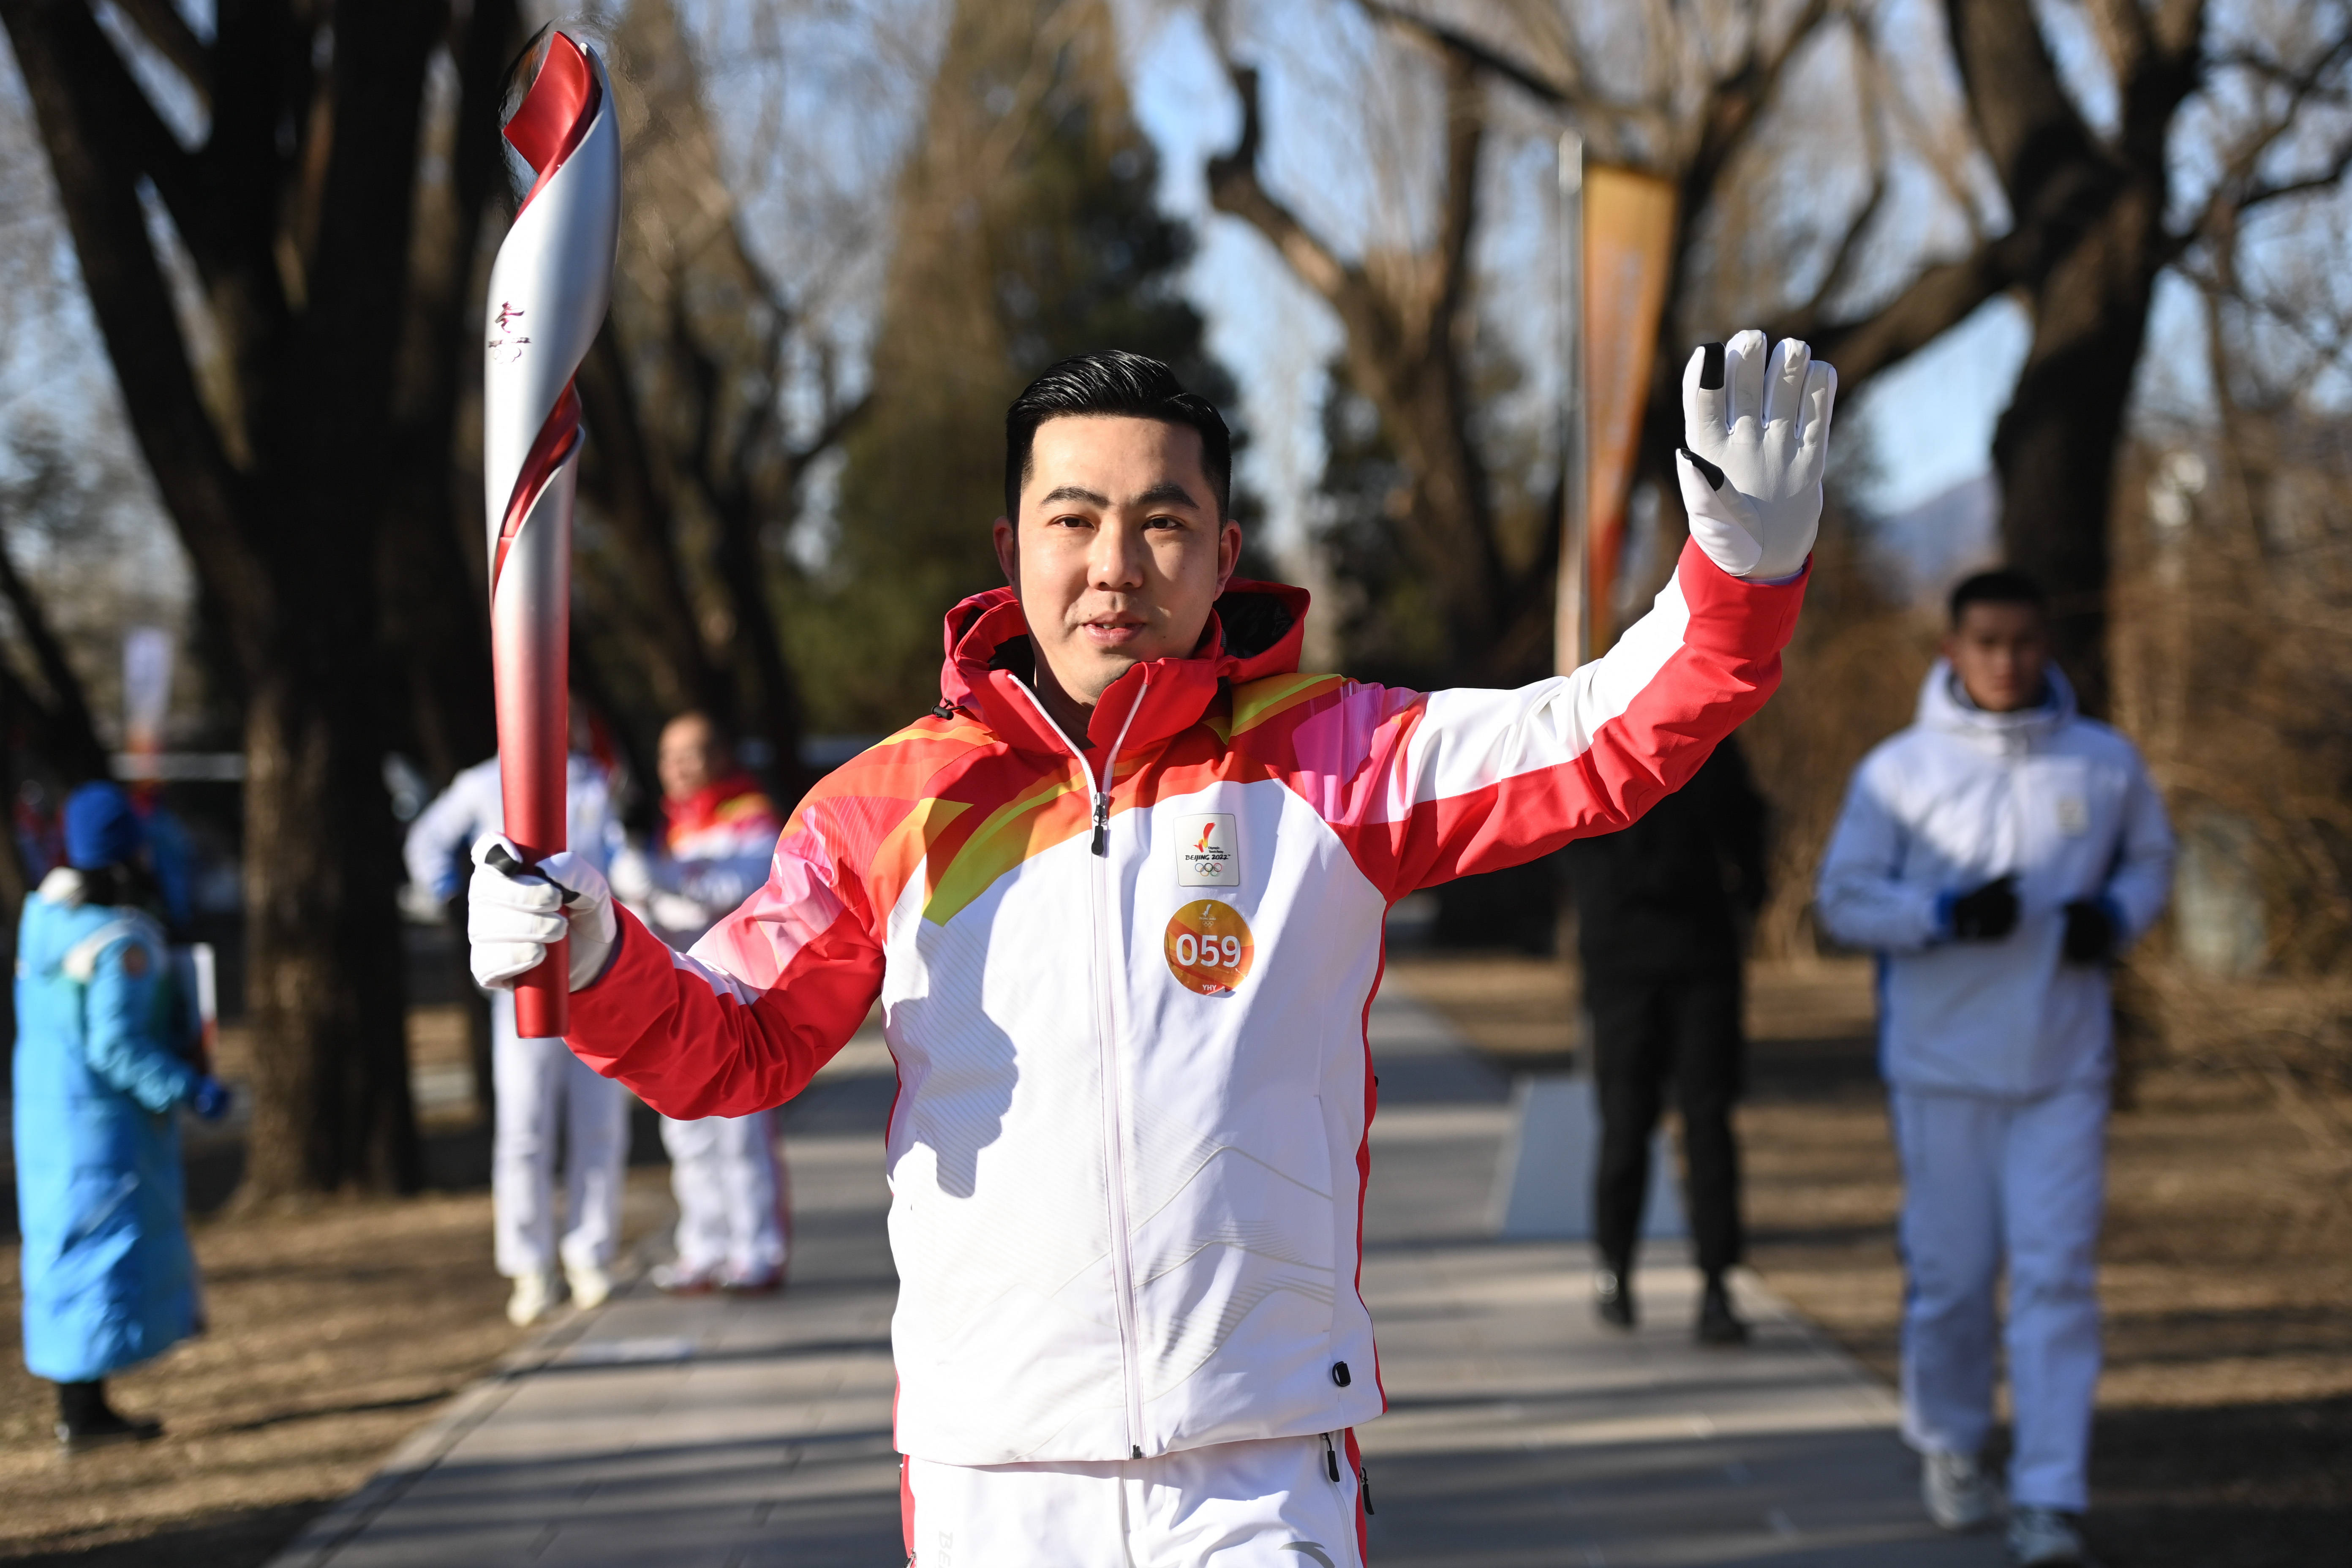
[{"xmin": 405, "ymin": 710, "xmax": 628, "ymax": 1328}]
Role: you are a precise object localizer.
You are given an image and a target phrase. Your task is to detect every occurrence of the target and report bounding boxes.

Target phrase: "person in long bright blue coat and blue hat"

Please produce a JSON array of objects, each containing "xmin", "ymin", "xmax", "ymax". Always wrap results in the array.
[{"xmin": 16, "ymin": 783, "xmax": 228, "ymax": 1451}]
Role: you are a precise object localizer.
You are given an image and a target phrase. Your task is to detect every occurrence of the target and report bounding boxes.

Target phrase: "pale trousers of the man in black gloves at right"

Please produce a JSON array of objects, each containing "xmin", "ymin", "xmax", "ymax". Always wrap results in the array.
[{"xmin": 1891, "ymin": 1089, "xmax": 2107, "ymax": 1511}]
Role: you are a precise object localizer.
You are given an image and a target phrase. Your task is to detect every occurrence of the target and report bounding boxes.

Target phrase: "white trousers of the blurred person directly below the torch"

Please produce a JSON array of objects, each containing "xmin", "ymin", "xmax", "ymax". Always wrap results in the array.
[{"xmin": 489, "ymin": 990, "xmax": 628, "ymax": 1279}]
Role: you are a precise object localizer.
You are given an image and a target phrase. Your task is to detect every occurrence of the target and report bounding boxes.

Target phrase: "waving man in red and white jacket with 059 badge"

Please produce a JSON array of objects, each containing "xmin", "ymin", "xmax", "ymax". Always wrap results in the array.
[{"xmin": 471, "ymin": 332, "xmax": 1835, "ymax": 1568}]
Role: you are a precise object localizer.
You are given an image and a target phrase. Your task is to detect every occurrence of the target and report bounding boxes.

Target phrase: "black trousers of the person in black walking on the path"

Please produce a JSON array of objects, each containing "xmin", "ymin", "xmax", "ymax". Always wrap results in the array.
[{"xmin": 1585, "ymin": 966, "xmax": 1748, "ymax": 1274}]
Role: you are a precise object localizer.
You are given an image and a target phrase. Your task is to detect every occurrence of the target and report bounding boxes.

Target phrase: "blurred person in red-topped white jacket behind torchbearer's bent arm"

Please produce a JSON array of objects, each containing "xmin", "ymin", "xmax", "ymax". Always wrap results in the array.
[{"xmin": 612, "ymin": 712, "xmax": 790, "ymax": 1295}]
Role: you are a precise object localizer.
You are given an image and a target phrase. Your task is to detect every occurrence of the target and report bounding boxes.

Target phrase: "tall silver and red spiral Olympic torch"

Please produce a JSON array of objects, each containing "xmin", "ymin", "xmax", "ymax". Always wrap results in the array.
[{"xmin": 482, "ymin": 30, "xmax": 621, "ymax": 1039}]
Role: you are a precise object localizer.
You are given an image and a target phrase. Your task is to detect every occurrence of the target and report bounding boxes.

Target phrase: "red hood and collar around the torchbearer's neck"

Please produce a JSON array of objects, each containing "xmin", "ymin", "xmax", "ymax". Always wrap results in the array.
[{"xmin": 939, "ymin": 578, "xmax": 1310, "ymax": 752}]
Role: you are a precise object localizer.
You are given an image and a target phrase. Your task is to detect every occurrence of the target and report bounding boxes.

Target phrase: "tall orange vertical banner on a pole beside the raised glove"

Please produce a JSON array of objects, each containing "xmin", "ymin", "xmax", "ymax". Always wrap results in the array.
[{"xmin": 1560, "ymin": 167, "xmax": 1674, "ymax": 668}]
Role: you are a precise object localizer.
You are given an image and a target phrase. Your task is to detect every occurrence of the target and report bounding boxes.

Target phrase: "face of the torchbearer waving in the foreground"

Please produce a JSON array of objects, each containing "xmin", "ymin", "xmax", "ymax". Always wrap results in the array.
[{"xmin": 995, "ymin": 416, "xmax": 1242, "ymax": 705}]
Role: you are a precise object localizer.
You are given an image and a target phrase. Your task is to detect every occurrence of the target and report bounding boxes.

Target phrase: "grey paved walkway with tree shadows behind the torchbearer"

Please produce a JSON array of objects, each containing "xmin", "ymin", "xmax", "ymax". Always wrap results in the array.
[{"xmin": 278, "ymin": 999, "xmax": 2001, "ymax": 1568}]
